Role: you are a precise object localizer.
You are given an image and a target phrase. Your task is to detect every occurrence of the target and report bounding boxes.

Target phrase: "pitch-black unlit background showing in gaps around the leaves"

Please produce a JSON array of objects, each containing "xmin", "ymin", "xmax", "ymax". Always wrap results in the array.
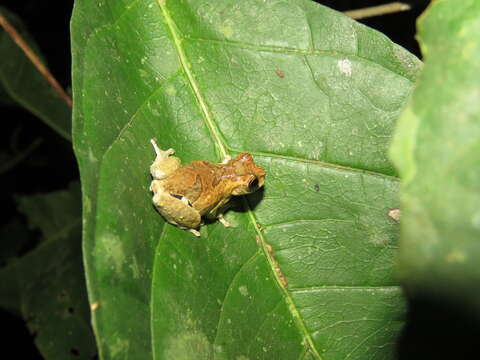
[{"xmin": 4, "ymin": 0, "xmax": 480, "ymax": 360}]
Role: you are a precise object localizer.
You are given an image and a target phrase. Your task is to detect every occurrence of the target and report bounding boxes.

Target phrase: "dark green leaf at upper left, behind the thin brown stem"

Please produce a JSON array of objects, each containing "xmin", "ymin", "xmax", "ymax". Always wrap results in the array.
[{"xmin": 0, "ymin": 7, "xmax": 71, "ymax": 141}]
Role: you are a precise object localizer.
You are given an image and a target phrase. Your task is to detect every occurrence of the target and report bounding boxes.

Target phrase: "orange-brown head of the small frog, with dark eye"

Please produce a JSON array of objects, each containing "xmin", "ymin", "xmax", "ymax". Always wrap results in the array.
[{"xmin": 231, "ymin": 153, "xmax": 265, "ymax": 195}]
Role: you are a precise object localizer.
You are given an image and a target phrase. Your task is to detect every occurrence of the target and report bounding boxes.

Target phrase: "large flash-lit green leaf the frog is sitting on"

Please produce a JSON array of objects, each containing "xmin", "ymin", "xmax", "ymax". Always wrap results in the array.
[{"xmin": 72, "ymin": 0, "xmax": 420, "ymax": 359}]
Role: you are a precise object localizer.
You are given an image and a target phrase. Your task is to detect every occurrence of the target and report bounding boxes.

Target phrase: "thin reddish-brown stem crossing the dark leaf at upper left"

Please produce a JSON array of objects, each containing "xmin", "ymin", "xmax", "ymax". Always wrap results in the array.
[{"xmin": 0, "ymin": 13, "xmax": 72, "ymax": 108}]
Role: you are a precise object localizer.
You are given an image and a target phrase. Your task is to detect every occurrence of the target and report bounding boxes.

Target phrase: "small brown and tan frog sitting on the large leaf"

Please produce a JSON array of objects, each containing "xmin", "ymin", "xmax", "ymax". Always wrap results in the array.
[{"xmin": 150, "ymin": 139, "xmax": 265, "ymax": 236}]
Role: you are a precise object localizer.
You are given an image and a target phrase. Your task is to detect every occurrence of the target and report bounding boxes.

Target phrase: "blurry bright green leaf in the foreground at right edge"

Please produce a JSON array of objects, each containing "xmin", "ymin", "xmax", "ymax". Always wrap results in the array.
[{"xmin": 391, "ymin": 0, "xmax": 480, "ymax": 309}]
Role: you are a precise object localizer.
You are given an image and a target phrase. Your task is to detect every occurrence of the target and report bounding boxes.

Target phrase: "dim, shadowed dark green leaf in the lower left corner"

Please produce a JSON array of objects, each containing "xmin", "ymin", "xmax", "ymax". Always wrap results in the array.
[{"xmin": 0, "ymin": 183, "xmax": 96, "ymax": 359}]
